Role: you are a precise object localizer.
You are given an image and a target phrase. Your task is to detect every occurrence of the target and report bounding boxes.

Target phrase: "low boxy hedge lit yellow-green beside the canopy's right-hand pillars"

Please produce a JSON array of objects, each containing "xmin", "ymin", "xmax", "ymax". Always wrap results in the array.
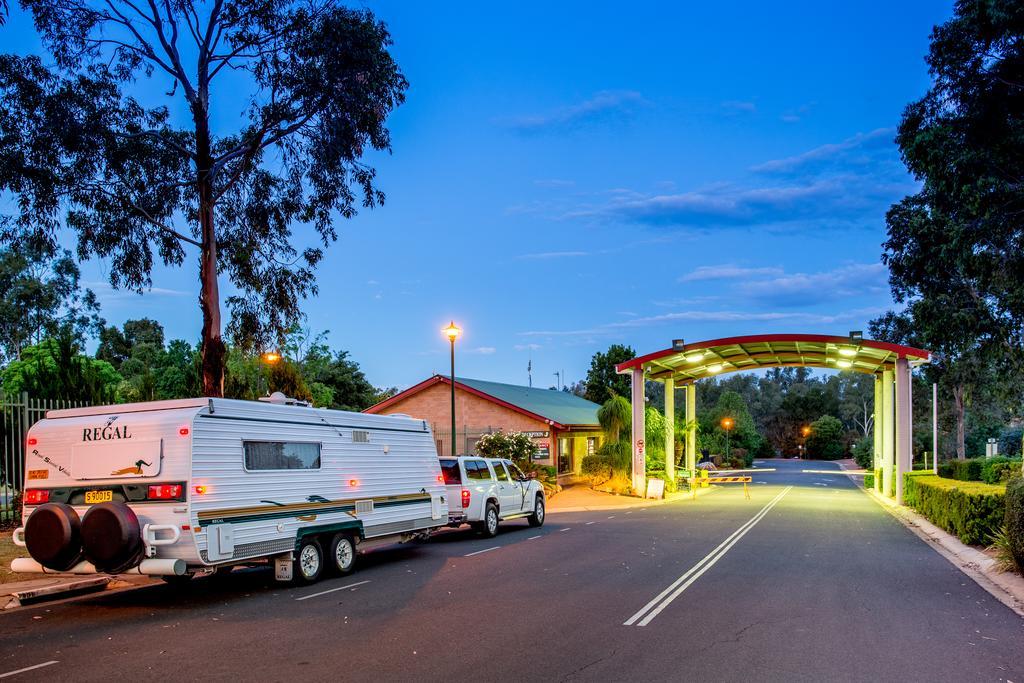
[{"xmin": 903, "ymin": 472, "xmax": 1006, "ymax": 546}]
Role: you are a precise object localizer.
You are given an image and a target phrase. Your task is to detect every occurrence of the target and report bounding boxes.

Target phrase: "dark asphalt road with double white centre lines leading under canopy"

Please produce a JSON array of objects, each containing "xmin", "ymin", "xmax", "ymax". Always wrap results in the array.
[{"xmin": 0, "ymin": 461, "xmax": 1024, "ymax": 683}]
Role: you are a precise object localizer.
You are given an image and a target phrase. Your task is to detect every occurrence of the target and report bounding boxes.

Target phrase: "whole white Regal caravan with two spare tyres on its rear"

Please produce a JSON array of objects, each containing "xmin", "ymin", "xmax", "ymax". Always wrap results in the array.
[{"xmin": 11, "ymin": 394, "xmax": 449, "ymax": 582}]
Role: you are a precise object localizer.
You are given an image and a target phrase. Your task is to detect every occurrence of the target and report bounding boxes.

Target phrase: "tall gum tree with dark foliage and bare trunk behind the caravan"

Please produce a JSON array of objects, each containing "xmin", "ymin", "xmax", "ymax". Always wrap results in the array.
[{"xmin": 0, "ymin": 0, "xmax": 407, "ymax": 395}]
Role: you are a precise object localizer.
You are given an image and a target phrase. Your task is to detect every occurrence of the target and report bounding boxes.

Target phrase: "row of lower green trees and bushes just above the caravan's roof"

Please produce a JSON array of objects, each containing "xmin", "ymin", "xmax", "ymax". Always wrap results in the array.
[{"xmin": 0, "ymin": 244, "xmax": 395, "ymax": 411}]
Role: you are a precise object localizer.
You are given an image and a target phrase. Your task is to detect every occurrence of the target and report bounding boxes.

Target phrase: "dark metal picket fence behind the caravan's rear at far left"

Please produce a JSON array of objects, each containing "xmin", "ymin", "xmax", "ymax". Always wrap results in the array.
[{"xmin": 0, "ymin": 392, "xmax": 89, "ymax": 526}]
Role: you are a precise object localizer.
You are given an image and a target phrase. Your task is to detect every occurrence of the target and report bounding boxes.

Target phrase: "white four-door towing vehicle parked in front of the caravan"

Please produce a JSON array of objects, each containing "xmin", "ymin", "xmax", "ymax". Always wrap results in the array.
[{"xmin": 440, "ymin": 456, "xmax": 544, "ymax": 538}]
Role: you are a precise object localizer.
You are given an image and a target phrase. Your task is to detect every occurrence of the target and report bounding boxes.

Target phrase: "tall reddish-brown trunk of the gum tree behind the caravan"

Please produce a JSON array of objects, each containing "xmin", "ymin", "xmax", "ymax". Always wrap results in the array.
[{"xmin": 193, "ymin": 97, "xmax": 226, "ymax": 396}]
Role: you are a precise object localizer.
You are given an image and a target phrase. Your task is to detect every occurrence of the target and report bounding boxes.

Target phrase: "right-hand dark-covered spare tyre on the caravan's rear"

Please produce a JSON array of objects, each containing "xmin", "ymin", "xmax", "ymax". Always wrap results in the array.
[{"xmin": 82, "ymin": 502, "xmax": 143, "ymax": 573}]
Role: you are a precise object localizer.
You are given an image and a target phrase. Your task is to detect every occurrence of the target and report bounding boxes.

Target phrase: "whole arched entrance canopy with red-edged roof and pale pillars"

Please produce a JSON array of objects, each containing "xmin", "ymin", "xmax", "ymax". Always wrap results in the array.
[{"xmin": 615, "ymin": 332, "xmax": 931, "ymax": 503}]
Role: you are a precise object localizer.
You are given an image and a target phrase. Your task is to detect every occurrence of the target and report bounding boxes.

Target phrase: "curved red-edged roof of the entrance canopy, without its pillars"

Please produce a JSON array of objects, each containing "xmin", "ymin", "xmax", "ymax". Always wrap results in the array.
[{"xmin": 615, "ymin": 335, "xmax": 930, "ymax": 383}]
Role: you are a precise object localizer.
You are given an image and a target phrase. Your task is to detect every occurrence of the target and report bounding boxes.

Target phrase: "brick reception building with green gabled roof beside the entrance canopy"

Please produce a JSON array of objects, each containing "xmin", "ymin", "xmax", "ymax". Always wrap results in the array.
[{"xmin": 366, "ymin": 375, "xmax": 602, "ymax": 479}]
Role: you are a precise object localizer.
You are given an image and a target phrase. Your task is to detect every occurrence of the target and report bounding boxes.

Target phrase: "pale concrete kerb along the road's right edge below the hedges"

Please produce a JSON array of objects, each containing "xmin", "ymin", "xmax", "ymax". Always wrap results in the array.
[{"xmin": 863, "ymin": 488, "xmax": 1024, "ymax": 616}]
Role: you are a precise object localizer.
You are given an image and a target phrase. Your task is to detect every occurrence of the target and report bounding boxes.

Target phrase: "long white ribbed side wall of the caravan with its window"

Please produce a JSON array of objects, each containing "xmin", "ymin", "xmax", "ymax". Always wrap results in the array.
[{"xmin": 190, "ymin": 400, "xmax": 447, "ymax": 563}]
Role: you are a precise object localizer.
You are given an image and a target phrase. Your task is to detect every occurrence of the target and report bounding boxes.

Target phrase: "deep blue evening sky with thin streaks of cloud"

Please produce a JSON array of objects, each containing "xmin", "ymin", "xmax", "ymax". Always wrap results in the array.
[{"xmin": 3, "ymin": 0, "xmax": 951, "ymax": 387}]
